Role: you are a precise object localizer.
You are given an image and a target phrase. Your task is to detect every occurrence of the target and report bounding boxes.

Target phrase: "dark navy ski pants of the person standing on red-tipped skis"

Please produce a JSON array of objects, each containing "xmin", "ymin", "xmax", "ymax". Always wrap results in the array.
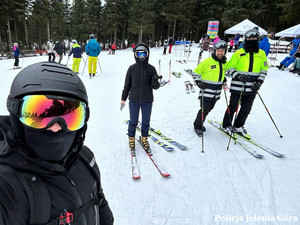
[{"xmin": 128, "ymin": 101, "xmax": 152, "ymax": 137}]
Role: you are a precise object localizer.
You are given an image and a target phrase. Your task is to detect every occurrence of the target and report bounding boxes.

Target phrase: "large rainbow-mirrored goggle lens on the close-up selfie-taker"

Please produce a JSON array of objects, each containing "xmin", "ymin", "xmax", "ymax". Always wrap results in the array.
[{"xmin": 19, "ymin": 95, "xmax": 88, "ymax": 131}]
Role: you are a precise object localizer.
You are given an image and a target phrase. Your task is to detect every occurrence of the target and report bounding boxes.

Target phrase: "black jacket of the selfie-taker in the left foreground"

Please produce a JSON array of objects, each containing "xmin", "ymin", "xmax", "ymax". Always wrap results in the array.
[{"xmin": 0, "ymin": 116, "xmax": 113, "ymax": 225}]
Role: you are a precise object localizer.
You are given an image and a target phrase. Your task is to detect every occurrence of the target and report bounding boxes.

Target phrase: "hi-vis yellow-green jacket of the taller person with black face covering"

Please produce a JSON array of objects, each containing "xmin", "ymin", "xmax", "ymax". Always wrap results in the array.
[{"xmin": 226, "ymin": 48, "xmax": 268, "ymax": 95}]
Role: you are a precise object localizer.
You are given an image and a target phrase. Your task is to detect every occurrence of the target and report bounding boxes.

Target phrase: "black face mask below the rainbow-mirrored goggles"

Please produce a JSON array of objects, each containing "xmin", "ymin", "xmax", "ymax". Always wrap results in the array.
[{"xmin": 24, "ymin": 127, "xmax": 76, "ymax": 162}]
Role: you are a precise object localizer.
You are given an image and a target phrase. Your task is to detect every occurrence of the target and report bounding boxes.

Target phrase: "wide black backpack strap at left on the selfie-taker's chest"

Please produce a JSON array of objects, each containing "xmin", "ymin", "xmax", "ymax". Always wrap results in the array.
[{"xmin": 19, "ymin": 172, "xmax": 51, "ymax": 224}]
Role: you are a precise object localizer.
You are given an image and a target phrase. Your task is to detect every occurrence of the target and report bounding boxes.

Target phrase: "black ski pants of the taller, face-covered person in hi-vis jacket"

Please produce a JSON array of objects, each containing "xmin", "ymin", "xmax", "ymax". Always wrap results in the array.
[{"xmin": 223, "ymin": 93, "xmax": 256, "ymax": 128}]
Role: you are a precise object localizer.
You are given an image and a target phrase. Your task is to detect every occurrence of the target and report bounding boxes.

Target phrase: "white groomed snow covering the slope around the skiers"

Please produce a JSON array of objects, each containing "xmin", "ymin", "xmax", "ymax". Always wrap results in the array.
[{"xmin": 0, "ymin": 45, "xmax": 300, "ymax": 225}]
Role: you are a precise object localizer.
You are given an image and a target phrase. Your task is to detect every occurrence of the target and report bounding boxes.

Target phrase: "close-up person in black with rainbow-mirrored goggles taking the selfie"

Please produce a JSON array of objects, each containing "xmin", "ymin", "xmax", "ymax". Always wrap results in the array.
[{"xmin": 0, "ymin": 62, "xmax": 113, "ymax": 225}]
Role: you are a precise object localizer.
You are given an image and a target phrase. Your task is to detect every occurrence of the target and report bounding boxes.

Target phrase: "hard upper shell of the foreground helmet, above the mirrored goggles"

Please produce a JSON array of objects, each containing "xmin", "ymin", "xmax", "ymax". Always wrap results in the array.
[{"xmin": 9, "ymin": 62, "xmax": 88, "ymax": 104}]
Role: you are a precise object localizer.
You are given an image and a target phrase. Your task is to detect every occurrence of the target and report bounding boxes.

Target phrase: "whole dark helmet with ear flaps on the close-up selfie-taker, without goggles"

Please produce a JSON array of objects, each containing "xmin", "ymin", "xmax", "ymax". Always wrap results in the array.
[{"xmin": 7, "ymin": 62, "xmax": 89, "ymax": 142}]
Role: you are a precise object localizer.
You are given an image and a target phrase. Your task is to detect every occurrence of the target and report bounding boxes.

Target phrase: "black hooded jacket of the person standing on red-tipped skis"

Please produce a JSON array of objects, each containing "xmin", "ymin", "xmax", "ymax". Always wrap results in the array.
[{"xmin": 122, "ymin": 44, "xmax": 160, "ymax": 102}]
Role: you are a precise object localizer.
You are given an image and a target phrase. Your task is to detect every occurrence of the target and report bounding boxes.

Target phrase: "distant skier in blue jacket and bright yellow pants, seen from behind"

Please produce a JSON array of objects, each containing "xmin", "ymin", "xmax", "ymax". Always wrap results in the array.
[{"xmin": 85, "ymin": 34, "xmax": 101, "ymax": 77}]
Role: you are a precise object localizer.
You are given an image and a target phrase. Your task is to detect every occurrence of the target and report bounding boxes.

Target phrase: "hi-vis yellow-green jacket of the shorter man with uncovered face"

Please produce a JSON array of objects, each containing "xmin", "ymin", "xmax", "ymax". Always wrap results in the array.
[{"xmin": 192, "ymin": 57, "xmax": 227, "ymax": 101}]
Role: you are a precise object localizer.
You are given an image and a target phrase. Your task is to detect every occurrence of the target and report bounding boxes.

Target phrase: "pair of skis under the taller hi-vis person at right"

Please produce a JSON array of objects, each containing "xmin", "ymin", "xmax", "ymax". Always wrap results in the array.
[{"xmin": 208, "ymin": 120, "xmax": 284, "ymax": 158}]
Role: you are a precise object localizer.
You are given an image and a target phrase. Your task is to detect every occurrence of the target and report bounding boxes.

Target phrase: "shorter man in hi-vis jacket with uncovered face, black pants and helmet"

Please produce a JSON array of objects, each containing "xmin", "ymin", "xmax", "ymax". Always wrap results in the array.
[{"xmin": 192, "ymin": 41, "xmax": 227, "ymax": 137}]
